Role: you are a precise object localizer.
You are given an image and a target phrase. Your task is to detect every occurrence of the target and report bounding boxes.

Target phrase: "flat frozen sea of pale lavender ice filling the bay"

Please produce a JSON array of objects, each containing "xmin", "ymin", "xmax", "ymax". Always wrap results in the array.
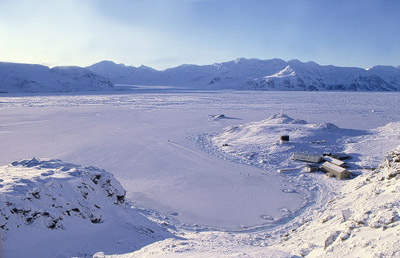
[{"xmin": 0, "ymin": 90, "xmax": 400, "ymax": 231}]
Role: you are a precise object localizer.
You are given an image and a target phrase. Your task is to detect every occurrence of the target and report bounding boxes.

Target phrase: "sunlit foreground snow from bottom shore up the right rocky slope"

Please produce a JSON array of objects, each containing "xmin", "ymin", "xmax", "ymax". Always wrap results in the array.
[{"xmin": 102, "ymin": 146, "xmax": 400, "ymax": 258}]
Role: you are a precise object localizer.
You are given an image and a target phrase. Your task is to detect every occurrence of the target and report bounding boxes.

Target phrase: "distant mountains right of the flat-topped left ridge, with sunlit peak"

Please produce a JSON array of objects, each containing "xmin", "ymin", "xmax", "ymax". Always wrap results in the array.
[{"xmin": 87, "ymin": 58, "xmax": 400, "ymax": 91}]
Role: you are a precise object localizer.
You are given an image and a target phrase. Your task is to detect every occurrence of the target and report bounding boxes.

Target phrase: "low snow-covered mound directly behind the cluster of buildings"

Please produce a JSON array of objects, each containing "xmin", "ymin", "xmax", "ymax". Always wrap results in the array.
[{"xmin": 209, "ymin": 114, "xmax": 346, "ymax": 170}]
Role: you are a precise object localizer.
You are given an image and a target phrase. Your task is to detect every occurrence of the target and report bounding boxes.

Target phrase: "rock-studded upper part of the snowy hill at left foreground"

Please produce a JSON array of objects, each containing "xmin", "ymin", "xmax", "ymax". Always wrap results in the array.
[{"xmin": 0, "ymin": 158, "xmax": 125, "ymax": 235}]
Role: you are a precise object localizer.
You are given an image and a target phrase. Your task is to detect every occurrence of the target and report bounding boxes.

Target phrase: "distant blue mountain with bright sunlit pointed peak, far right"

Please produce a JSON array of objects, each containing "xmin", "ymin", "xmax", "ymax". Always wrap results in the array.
[{"xmin": 244, "ymin": 60, "xmax": 400, "ymax": 91}]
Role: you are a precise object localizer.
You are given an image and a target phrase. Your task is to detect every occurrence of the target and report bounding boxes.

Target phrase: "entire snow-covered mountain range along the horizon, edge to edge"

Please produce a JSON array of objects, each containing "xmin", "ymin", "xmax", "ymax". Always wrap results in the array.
[{"xmin": 0, "ymin": 58, "xmax": 400, "ymax": 93}]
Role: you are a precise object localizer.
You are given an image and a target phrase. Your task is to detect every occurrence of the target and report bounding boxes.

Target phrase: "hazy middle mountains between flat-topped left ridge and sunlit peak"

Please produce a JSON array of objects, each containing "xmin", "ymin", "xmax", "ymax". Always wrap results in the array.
[{"xmin": 86, "ymin": 58, "xmax": 286, "ymax": 89}]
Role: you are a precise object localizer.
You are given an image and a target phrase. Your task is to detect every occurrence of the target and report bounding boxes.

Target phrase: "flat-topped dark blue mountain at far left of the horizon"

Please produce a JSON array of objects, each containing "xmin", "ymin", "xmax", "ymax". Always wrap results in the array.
[{"xmin": 0, "ymin": 62, "xmax": 113, "ymax": 93}]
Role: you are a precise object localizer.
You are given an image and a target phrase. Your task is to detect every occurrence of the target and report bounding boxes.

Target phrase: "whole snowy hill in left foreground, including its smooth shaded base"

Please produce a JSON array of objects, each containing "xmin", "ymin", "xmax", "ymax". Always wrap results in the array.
[{"xmin": 0, "ymin": 158, "xmax": 171, "ymax": 257}]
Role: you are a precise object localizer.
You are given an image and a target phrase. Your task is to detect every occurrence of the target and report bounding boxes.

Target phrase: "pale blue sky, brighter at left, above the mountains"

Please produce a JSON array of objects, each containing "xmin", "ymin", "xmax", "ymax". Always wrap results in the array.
[{"xmin": 0, "ymin": 0, "xmax": 400, "ymax": 69}]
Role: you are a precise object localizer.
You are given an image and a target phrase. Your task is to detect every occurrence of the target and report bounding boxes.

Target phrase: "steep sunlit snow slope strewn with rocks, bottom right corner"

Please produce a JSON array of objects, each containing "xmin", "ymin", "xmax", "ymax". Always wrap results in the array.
[{"xmin": 275, "ymin": 146, "xmax": 400, "ymax": 257}]
